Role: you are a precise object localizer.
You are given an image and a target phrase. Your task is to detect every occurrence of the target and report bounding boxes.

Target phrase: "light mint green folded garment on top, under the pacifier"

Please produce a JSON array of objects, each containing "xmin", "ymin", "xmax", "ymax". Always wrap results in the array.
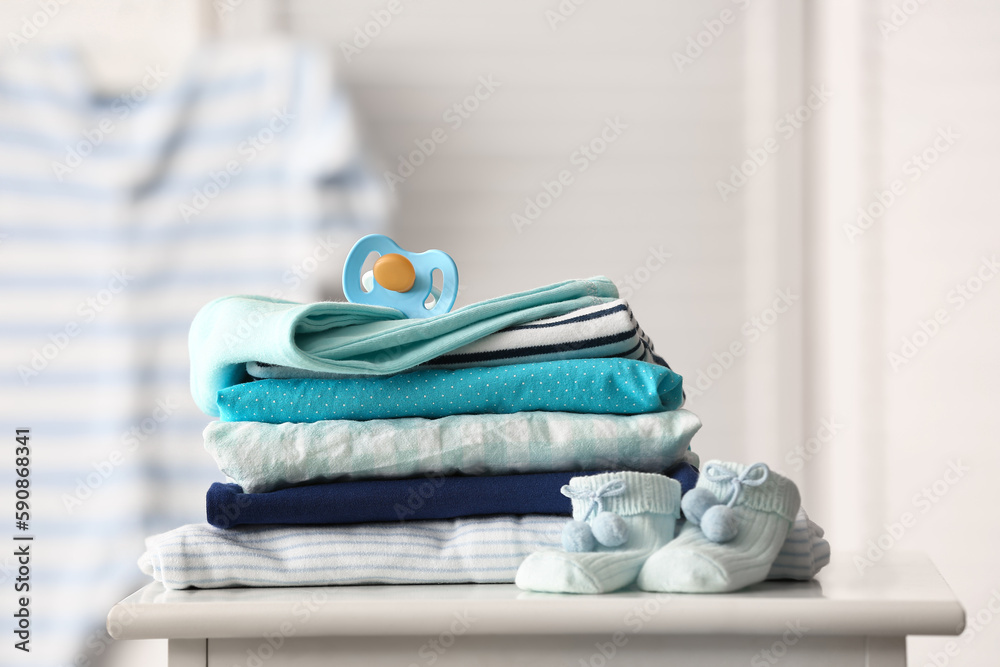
[{"xmin": 188, "ymin": 277, "xmax": 618, "ymax": 416}]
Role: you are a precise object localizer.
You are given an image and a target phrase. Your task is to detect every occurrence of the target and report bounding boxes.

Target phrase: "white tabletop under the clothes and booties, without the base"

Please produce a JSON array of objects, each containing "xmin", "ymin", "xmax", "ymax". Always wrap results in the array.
[{"xmin": 108, "ymin": 553, "xmax": 965, "ymax": 639}]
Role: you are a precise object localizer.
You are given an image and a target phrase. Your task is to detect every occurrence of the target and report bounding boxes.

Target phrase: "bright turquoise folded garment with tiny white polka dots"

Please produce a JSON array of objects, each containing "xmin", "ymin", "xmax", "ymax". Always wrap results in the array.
[{"xmin": 218, "ymin": 359, "xmax": 683, "ymax": 424}]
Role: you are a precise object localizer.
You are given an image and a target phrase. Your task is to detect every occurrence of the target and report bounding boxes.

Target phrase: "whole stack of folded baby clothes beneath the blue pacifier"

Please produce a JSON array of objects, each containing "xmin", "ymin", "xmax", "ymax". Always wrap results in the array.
[{"xmin": 140, "ymin": 278, "xmax": 828, "ymax": 588}]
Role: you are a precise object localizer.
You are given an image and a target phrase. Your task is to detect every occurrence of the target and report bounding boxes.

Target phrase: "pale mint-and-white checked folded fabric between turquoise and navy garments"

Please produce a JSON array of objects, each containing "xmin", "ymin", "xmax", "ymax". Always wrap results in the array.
[{"xmin": 205, "ymin": 410, "xmax": 701, "ymax": 493}]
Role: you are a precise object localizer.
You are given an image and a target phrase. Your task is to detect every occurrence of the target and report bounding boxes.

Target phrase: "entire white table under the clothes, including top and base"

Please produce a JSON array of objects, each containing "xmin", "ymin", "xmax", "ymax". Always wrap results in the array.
[{"xmin": 108, "ymin": 553, "xmax": 965, "ymax": 667}]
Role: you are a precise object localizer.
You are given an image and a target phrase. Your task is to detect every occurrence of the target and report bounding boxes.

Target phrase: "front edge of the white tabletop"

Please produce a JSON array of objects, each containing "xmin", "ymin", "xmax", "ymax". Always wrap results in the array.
[{"xmin": 107, "ymin": 596, "xmax": 965, "ymax": 639}]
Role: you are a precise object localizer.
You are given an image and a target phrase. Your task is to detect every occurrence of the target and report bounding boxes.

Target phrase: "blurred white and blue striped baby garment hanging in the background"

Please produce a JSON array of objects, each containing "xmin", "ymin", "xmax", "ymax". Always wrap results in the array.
[{"xmin": 0, "ymin": 43, "xmax": 384, "ymax": 666}]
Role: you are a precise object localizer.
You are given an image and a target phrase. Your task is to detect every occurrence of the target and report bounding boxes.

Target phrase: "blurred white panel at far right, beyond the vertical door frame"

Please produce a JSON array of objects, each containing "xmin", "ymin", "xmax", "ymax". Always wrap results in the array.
[{"xmin": 876, "ymin": 0, "xmax": 1000, "ymax": 666}]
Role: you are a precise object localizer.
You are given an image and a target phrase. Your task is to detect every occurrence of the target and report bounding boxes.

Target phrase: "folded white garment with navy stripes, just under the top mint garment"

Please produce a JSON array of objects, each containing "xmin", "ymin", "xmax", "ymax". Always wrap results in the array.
[{"xmin": 247, "ymin": 299, "xmax": 670, "ymax": 380}]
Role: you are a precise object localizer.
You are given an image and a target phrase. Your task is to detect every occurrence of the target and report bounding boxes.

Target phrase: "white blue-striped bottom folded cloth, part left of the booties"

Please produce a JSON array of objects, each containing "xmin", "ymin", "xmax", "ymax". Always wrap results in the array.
[{"xmin": 139, "ymin": 516, "xmax": 566, "ymax": 589}]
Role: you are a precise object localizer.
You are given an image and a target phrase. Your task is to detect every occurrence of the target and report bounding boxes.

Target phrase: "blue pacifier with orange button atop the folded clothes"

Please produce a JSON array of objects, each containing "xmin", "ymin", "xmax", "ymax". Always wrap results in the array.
[{"xmin": 344, "ymin": 234, "xmax": 458, "ymax": 319}]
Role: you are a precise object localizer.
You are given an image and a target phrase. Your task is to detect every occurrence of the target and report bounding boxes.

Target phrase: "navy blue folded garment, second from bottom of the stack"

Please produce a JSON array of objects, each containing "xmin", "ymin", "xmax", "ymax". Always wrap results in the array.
[{"xmin": 205, "ymin": 463, "xmax": 698, "ymax": 528}]
